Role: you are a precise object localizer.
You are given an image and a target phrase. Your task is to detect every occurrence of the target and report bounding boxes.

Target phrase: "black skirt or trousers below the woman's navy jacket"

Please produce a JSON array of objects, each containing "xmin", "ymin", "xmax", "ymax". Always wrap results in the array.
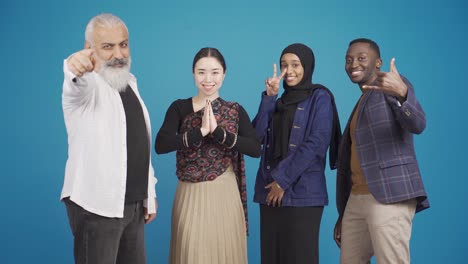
[{"xmin": 260, "ymin": 204, "xmax": 323, "ymax": 264}]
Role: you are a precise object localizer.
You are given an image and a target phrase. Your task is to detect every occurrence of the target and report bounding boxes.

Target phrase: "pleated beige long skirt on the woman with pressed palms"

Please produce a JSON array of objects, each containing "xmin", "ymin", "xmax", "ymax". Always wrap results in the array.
[{"xmin": 169, "ymin": 168, "xmax": 247, "ymax": 264}]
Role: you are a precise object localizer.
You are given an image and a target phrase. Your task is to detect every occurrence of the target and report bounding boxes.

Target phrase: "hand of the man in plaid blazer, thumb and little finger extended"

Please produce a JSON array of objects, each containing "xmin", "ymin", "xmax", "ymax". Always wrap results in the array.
[{"xmin": 362, "ymin": 58, "xmax": 408, "ymax": 102}]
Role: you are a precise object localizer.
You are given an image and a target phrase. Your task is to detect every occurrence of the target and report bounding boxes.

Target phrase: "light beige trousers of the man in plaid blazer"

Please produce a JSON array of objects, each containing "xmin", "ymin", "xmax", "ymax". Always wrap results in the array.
[{"xmin": 340, "ymin": 194, "xmax": 416, "ymax": 264}]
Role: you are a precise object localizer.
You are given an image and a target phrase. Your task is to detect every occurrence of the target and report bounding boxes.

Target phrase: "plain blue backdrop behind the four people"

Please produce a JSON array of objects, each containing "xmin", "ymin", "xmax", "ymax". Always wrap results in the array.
[{"xmin": 0, "ymin": 0, "xmax": 468, "ymax": 263}]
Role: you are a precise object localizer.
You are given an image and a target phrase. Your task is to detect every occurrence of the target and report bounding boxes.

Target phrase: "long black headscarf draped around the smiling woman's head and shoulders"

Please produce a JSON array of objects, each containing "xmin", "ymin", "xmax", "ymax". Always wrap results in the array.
[{"xmin": 273, "ymin": 43, "xmax": 341, "ymax": 169}]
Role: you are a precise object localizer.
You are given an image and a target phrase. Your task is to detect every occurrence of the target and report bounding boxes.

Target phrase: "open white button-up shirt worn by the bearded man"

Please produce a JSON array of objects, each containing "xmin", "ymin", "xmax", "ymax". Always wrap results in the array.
[{"xmin": 60, "ymin": 60, "xmax": 157, "ymax": 218}]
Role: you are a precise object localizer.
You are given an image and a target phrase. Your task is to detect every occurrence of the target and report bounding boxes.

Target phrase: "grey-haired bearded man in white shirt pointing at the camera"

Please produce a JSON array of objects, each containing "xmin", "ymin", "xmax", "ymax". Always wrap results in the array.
[{"xmin": 61, "ymin": 14, "xmax": 157, "ymax": 264}]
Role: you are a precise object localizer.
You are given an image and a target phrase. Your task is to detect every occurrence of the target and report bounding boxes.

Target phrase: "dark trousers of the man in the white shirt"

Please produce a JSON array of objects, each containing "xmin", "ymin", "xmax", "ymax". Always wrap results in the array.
[{"xmin": 64, "ymin": 198, "xmax": 146, "ymax": 264}]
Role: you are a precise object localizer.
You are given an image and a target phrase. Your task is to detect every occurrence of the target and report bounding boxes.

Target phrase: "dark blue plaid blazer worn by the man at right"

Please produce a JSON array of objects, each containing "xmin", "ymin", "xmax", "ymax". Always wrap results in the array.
[{"xmin": 336, "ymin": 76, "xmax": 429, "ymax": 217}]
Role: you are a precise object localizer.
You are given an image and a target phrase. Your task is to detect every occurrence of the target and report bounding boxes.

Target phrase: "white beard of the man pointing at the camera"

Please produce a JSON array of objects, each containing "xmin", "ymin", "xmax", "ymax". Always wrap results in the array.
[{"xmin": 98, "ymin": 57, "xmax": 131, "ymax": 92}]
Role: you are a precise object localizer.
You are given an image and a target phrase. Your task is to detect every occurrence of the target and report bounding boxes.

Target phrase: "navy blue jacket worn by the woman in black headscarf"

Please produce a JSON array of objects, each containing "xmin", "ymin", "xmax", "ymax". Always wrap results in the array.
[{"xmin": 253, "ymin": 89, "xmax": 333, "ymax": 207}]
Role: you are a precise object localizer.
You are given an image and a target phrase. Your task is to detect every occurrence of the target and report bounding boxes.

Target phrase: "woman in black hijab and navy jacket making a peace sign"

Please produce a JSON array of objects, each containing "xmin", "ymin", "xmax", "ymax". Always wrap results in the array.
[{"xmin": 253, "ymin": 43, "xmax": 341, "ymax": 264}]
